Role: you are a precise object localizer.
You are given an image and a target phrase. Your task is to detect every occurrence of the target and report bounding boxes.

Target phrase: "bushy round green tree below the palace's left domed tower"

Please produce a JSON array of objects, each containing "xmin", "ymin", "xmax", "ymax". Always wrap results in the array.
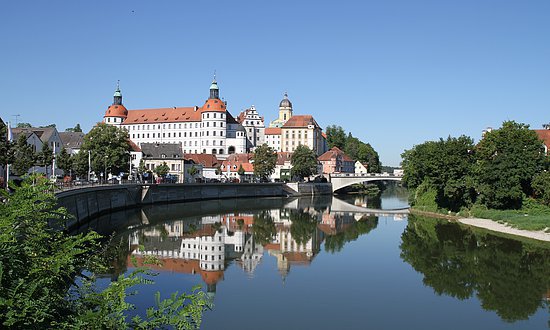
[{"xmin": 75, "ymin": 123, "xmax": 131, "ymax": 179}]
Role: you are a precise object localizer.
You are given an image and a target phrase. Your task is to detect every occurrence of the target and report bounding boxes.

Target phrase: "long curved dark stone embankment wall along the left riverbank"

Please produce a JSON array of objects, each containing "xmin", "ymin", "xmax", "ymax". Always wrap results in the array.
[{"xmin": 56, "ymin": 183, "xmax": 287, "ymax": 227}]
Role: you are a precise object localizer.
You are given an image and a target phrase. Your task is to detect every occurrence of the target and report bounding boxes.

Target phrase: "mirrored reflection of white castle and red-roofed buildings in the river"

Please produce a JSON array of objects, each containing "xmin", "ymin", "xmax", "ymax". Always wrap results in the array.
[{"xmin": 96, "ymin": 196, "xmax": 406, "ymax": 292}]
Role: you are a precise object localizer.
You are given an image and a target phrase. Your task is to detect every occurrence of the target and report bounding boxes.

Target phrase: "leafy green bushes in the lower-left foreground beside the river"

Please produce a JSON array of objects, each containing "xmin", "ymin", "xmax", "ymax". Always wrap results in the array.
[{"xmin": 0, "ymin": 177, "xmax": 210, "ymax": 329}]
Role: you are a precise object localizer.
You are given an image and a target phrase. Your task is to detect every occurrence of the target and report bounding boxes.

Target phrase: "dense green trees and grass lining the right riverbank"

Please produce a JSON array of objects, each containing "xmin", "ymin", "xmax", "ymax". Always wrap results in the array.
[{"xmin": 402, "ymin": 121, "xmax": 550, "ymax": 230}]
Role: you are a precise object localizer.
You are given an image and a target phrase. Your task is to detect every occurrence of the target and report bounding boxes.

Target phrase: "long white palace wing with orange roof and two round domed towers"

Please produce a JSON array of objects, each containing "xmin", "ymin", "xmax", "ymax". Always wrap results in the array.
[{"xmin": 103, "ymin": 79, "xmax": 248, "ymax": 157}]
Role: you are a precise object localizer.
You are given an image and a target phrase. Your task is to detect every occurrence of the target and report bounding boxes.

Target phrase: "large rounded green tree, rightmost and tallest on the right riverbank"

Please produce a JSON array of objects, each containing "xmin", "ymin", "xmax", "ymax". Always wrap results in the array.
[{"xmin": 475, "ymin": 121, "xmax": 545, "ymax": 209}]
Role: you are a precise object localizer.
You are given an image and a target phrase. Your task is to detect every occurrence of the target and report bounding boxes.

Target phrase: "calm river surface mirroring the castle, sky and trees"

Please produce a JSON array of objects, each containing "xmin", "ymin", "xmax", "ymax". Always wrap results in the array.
[{"xmin": 85, "ymin": 189, "xmax": 550, "ymax": 329}]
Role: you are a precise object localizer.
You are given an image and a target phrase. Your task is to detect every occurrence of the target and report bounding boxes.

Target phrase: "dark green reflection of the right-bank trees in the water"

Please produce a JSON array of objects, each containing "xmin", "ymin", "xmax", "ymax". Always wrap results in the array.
[{"xmin": 400, "ymin": 215, "xmax": 550, "ymax": 322}]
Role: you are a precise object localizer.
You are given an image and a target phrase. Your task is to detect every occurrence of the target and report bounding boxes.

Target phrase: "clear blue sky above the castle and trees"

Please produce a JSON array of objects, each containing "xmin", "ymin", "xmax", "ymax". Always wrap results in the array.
[{"xmin": 0, "ymin": 0, "xmax": 550, "ymax": 166}]
